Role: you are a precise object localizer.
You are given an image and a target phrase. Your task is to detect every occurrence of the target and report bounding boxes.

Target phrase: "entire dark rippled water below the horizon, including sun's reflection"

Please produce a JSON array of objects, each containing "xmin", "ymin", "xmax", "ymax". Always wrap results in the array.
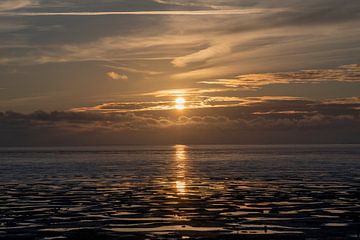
[{"xmin": 0, "ymin": 145, "xmax": 360, "ymax": 240}]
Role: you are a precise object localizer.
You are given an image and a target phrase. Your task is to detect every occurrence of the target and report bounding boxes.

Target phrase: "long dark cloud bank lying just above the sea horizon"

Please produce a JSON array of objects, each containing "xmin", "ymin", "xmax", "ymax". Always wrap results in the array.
[{"xmin": 0, "ymin": 99, "xmax": 360, "ymax": 146}]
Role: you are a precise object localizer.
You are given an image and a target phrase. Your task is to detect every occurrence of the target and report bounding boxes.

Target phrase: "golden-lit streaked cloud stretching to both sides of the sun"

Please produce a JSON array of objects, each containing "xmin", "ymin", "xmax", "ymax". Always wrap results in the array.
[{"xmin": 68, "ymin": 94, "xmax": 360, "ymax": 114}]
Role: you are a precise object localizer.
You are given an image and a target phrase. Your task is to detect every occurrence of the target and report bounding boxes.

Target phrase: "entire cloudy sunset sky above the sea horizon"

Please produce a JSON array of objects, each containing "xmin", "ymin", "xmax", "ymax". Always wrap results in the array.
[{"xmin": 0, "ymin": 0, "xmax": 360, "ymax": 146}]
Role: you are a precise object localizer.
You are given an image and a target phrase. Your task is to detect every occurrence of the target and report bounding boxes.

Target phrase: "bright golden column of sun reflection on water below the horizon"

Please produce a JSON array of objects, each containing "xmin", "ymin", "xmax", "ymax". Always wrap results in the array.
[{"xmin": 174, "ymin": 145, "xmax": 188, "ymax": 195}]
